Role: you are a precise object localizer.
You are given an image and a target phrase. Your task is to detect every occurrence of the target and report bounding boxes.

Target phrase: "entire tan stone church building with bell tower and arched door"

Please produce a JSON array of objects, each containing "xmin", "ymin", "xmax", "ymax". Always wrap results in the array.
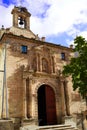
[{"xmin": 0, "ymin": 7, "xmax": 85, "ymax": 126}]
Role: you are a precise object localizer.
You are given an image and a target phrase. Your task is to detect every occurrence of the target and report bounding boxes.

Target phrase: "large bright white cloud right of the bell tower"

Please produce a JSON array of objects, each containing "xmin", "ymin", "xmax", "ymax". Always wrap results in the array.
[{"xmin": 31, "ymin": 0, "xmax": 87, "ymax": 35}]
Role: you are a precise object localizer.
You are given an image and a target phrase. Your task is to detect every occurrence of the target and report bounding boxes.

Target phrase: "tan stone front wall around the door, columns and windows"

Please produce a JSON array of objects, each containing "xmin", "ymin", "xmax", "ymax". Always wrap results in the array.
[{"xmin": 0, "ymin": 35, "xmax": 85, "ymax": 126}]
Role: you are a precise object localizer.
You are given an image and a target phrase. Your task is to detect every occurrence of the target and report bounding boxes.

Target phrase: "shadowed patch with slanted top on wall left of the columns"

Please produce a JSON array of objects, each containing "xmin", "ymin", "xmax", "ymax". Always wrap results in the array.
[{"xmin": 7, "ymin": 66, "xmax": 23, "ymax": 117}]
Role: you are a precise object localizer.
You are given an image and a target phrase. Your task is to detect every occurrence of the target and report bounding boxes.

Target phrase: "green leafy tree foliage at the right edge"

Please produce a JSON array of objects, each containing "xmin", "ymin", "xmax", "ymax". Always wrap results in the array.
[{"xmin": 63, "ymin": 36, "xmax": 87, "ymax": 96}]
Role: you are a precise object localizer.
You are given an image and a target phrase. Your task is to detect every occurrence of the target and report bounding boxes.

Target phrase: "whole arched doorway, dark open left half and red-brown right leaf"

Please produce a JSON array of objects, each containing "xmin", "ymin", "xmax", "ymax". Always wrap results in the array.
[{"xmin": 38, "ymin": 85, "xmax": 57, "ymax": 126}]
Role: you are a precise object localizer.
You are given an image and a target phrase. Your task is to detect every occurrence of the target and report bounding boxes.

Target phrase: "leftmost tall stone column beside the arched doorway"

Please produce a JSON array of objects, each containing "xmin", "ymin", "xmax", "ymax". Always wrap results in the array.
[{"xmin": 23, "ymin": 78, "xmax": 27, "ymax": 118}]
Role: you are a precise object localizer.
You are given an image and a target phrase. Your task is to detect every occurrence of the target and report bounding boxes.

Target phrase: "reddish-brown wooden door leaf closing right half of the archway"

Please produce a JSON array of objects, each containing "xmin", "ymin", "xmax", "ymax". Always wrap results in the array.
[{"xmin": 45, "ymin": 86, "xmax": 57, "ymax": 125}]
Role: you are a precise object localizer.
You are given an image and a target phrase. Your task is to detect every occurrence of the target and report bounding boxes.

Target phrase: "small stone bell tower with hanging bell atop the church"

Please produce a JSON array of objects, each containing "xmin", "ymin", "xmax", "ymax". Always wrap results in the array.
[{"xmin": 11, "ymin": 6, "xmax": 31, "ymax": 30}]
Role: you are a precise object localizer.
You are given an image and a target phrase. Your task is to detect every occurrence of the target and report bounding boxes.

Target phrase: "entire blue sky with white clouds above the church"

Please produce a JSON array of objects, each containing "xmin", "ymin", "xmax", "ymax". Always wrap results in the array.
[{"xmin": 0, "ymin": 0, "xmax": 87, "ymax": 46}]
